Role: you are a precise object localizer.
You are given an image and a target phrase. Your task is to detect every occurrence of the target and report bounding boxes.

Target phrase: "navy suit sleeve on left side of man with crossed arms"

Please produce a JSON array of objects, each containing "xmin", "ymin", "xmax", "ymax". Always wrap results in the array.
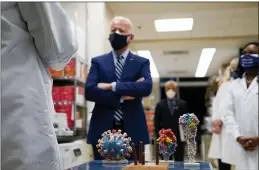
[{"xmin": 85, "ymin": 59, "xmax": 121, "ymax": 108}]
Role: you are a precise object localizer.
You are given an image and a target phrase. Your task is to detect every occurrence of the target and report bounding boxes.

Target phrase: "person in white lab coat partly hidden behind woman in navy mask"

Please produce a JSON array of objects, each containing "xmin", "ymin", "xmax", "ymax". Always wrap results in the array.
[{"xmin": 208, "ymin": 58, "xmax": 238, "ymax": 170}]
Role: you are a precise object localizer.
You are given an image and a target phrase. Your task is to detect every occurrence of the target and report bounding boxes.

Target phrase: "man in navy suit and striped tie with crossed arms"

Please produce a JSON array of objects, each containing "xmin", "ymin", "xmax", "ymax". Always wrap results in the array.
[{"xmin": 85, "ymin": 17, "xmax": 152, "ymax": 160}]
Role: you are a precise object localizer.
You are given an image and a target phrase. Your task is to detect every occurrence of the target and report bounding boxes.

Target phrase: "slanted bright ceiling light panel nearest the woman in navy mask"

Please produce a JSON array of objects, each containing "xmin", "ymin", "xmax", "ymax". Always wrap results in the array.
[{"xmin": 195, "ymin": 48, "xmax": 216, "ymax": 77}]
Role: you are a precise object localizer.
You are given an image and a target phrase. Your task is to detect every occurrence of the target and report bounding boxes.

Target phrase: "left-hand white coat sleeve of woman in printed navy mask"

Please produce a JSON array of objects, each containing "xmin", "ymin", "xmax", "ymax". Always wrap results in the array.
[{"xmin": 219, "ymin": 86, "xmax": 241, "ymax": 140}]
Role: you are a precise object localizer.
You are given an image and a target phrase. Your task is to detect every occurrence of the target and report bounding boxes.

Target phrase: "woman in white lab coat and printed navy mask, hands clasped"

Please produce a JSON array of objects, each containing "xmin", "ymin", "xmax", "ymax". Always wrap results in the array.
[{"xmin": 222, "ymin": 42, "xmax": 259, "ymax": 170}]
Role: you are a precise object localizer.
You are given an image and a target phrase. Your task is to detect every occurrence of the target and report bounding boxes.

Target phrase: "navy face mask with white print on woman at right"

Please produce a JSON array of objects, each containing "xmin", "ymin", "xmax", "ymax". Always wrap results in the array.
[{"xmin": 240, "ymin": 54, "xmax": 259, "ymax": 72}]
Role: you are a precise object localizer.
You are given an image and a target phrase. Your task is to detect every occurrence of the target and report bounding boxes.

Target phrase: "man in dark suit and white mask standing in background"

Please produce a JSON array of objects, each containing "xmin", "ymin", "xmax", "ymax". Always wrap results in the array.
[{"xmin": 154, "ymin": 81, "xmax": 188, "ymax": 161}]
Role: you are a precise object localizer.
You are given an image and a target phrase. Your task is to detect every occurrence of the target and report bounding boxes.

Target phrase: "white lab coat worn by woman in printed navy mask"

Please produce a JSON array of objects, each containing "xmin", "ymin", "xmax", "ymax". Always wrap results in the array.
[{"xmin": 220, "ymin": 78, "xmax": 258, "ymax": 170}]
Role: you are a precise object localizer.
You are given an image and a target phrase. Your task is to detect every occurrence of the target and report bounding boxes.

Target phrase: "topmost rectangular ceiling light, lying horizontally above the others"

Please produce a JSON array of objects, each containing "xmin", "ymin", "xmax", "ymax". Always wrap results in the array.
[{"xmin": 154, "ymin": 18, "xmax": 193, "ymax": 32}]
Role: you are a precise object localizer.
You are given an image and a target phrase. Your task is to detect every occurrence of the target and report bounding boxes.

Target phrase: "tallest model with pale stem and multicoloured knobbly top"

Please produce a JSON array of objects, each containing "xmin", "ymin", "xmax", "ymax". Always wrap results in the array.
[{"xmin": 179, "ymin": 113, "xmax": 200, "ymax": 167}]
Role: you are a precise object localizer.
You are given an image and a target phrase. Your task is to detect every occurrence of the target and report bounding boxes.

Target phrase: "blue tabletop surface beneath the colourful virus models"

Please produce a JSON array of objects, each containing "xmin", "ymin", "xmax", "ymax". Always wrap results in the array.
[{"xmin": 68, "ymin": 161, "xmax": 213, "ymax": 170}]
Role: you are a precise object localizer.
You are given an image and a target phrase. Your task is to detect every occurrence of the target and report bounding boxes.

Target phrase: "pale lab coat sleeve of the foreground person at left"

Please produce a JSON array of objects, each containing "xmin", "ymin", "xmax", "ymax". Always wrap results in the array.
[{"xmin": 18, "ymin": 2, "xmax": 78, "ymax": 70}]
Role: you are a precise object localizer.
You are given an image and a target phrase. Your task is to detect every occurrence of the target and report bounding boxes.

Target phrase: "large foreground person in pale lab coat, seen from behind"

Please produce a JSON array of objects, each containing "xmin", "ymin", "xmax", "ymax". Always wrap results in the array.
[{"xmin": 1, "ymin": 2, "xmax": 77, "ymax": 170}]
